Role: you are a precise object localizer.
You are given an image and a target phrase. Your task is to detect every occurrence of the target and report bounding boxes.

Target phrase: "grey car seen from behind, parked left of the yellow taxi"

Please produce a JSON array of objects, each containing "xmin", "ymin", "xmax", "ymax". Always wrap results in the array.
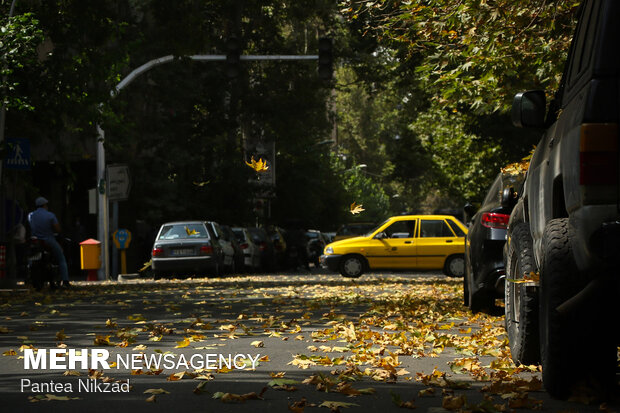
[{"xmin": 151, "ymin": 221, "xmax": 223, "ymax": 277}]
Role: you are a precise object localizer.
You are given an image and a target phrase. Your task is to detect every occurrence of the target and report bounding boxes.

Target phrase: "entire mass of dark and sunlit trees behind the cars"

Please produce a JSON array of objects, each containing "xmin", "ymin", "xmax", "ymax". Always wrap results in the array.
[{"xmin": 0, "ymin": 0, "xmax": 576, "ymax": 238}]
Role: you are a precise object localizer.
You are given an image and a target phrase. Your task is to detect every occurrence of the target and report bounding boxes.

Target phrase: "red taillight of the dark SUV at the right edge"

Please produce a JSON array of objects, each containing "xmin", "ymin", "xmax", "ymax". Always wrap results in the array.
[{"xmin": 579, "ymin": 123, "xmax": 618, "ymax": 185}]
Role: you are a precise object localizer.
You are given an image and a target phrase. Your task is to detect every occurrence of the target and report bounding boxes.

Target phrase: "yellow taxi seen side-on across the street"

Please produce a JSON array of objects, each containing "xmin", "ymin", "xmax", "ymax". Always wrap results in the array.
[{"xmin": 320, "ymin": 215, "xmax": 467, "ymax": 278}]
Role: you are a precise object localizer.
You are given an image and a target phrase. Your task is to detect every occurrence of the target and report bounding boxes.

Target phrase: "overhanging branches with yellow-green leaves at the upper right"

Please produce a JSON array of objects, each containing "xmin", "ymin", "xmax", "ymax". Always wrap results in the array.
[{"xmin": 343, "ymin": 0, "xmax": 579, "ymax": 113}]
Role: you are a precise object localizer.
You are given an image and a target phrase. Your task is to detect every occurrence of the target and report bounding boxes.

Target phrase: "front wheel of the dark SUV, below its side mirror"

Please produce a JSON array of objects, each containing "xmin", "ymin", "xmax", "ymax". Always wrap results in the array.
[{"xmin": 504, "ymin": 223, "xmax": 540, "ymax": 364}]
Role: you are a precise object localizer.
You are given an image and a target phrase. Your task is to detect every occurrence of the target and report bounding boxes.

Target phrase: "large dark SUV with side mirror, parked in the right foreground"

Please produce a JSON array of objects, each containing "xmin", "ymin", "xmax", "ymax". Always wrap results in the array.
[{"xmin": 504, "ymin": 0, "xmax": 620, "ymax": 398}]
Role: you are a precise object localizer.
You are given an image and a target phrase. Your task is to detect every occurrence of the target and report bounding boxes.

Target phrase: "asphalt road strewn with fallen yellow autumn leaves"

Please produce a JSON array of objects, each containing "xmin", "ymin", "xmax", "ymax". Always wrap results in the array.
[{"xmin": 0, "ymin": 273, "xmax": 620, "ymax": 412}]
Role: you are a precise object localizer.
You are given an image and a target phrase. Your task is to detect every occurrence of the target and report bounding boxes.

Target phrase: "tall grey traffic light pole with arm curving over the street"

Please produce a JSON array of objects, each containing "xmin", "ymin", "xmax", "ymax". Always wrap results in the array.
[{"xmin": 97, "ymin": 50, "xmax": 319, "ymax": 280}]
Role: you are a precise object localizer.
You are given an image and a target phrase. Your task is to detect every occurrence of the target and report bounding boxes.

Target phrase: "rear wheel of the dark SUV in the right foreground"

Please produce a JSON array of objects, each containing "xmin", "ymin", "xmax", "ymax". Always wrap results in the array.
[{"xmin": 540, "ymin": 218, "xmax": 617, "ymax": 398}]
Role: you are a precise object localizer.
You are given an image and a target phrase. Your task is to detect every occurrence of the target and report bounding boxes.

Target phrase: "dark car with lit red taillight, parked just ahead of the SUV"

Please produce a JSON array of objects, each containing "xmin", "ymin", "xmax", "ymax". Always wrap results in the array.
[{"xmin": 463, "ymin": 172, "xmax": 524, "ymax": 313}]
